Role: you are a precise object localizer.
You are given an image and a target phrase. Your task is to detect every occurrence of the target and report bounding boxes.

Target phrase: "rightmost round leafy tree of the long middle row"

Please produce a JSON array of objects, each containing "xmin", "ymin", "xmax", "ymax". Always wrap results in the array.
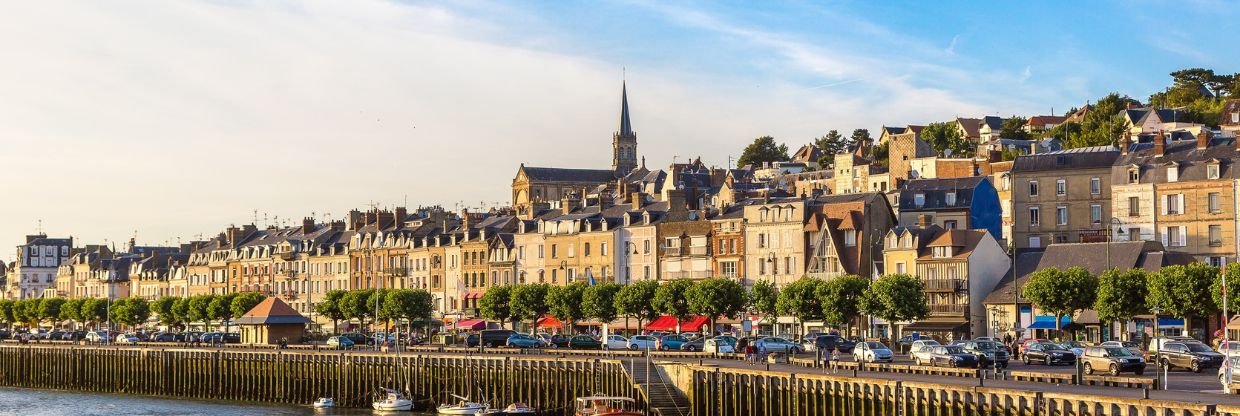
[{"xmin": 861, "ymin": 273, "xmax": 930, "ymax": 335}]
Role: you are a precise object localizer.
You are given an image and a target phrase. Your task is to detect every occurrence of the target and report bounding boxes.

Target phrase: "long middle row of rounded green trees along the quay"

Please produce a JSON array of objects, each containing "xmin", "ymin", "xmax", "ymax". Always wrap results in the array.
[{"xmin": 479, "ymin": 274, "xmax": 929, "ymax": 337}]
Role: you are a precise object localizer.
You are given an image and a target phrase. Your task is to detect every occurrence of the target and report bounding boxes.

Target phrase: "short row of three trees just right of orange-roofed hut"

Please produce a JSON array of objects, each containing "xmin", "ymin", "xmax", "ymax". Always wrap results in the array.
[{"xmin": 315, "ymin": 289, "xmax": 435, "ymax": 330}]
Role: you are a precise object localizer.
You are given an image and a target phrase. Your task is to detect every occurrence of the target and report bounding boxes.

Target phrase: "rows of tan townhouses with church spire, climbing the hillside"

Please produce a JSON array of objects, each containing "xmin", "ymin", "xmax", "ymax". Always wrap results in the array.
[{"xmin": 7, "ymin": 89, "xmax": 1240, "ymax": 337}]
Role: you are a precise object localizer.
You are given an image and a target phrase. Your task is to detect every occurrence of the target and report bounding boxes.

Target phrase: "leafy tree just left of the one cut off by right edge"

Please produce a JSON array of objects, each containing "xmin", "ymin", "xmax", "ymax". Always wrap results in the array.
[{"xmin": 1146, "ymin": 262, "xmax": 1215, "ymax": 330}]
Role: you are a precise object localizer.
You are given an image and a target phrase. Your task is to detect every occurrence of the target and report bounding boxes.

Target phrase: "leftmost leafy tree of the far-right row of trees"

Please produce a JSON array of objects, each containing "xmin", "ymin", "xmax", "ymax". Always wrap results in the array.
[{"xmin": 1022, "ymin": 267, "xmax": 1099, "ymax": 332}]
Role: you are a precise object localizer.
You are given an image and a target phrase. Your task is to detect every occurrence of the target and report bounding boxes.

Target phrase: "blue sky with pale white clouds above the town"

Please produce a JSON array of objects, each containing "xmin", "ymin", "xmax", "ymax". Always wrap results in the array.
[{"xmin": 0, "ymin": 0, "xmax": 1240, "ymax": 258}]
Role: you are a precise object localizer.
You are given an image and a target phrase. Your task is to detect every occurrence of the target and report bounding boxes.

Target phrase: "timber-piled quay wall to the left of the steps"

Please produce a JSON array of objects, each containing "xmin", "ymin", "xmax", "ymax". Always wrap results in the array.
[{"xmin": 0, "ymin": 345, "xmax": 639, "ymax": 415}]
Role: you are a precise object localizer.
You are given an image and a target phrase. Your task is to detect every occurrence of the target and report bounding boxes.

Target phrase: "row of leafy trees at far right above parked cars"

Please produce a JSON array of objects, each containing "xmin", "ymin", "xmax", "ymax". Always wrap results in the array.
[{"xmin": 1022, "ymin": 262, "xmax": 1240, "ymax": 337}]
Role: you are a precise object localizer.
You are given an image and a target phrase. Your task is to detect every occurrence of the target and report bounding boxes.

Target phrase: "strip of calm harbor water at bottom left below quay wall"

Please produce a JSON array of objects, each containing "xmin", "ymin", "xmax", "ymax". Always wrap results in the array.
[{"xmin": 0, "ymin": 387, "xmax": 430, "ymax": 416}]
